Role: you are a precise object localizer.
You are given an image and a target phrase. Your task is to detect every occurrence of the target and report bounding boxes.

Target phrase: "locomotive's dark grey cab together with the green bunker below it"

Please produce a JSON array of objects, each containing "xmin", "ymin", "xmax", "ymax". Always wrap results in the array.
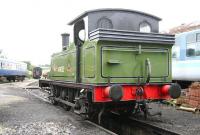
[{"xmin": 66, "ymin": 9, "xmax": 170, "ymax": 83}]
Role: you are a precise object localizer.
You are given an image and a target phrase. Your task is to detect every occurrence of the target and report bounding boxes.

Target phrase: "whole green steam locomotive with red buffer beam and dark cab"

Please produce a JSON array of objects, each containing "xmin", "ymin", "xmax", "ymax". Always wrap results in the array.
[{"xmin": 39, "ymin": 9, "xmax": 181, "ymax": 120}]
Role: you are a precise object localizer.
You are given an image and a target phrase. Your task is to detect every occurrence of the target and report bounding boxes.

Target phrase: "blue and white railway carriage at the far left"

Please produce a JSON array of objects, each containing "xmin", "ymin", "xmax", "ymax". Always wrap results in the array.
[{"xmin": 0, "ymin": 58, "xmax": 27, "ymax": 81}]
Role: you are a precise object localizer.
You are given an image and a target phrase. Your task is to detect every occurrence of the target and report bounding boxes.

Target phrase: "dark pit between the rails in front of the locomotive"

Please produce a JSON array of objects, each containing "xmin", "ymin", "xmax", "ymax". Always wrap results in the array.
[{"xmin": 99, "ymin": 112, "xmax": 180, "ymax": 135}]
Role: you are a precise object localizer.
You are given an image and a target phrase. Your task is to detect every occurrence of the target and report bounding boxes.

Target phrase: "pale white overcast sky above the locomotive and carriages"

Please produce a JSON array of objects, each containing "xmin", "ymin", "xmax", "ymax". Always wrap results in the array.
[{"xmin": 0, "ymin": 0, "xmax": 200, "ymax": 65}]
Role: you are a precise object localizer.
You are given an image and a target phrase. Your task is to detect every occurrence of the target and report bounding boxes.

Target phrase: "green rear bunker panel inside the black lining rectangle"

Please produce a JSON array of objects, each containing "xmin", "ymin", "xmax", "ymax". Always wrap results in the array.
[{"xmin": 102, "ymin": 47, "xmax": 168, "ymax": 77}]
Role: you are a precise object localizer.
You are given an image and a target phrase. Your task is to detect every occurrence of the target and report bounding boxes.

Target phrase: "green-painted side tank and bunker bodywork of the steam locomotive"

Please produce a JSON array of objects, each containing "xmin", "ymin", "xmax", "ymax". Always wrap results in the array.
[{"xmin": 50, "ymin": 41, "xmax": 172, "ymax": 84}]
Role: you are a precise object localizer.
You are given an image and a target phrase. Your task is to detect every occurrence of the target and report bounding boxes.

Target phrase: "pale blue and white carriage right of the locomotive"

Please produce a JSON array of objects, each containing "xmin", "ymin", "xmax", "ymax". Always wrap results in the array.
[{"xmin": 172, "ymin": 29, "xmax": 200, "ymax": 87}]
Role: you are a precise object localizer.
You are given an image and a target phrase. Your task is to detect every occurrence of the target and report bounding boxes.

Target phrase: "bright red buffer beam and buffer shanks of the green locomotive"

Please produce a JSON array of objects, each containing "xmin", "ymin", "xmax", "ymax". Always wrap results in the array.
[{"xmin": 93, "ymin": 85, "xmax": 170, "ymax": 102}]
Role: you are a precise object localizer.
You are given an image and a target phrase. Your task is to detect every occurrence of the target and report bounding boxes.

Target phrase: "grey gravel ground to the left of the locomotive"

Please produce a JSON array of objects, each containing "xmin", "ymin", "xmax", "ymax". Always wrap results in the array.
[{"xmin": 0, "ymin": 80, "xmax": 107, "ymax": 135}]
